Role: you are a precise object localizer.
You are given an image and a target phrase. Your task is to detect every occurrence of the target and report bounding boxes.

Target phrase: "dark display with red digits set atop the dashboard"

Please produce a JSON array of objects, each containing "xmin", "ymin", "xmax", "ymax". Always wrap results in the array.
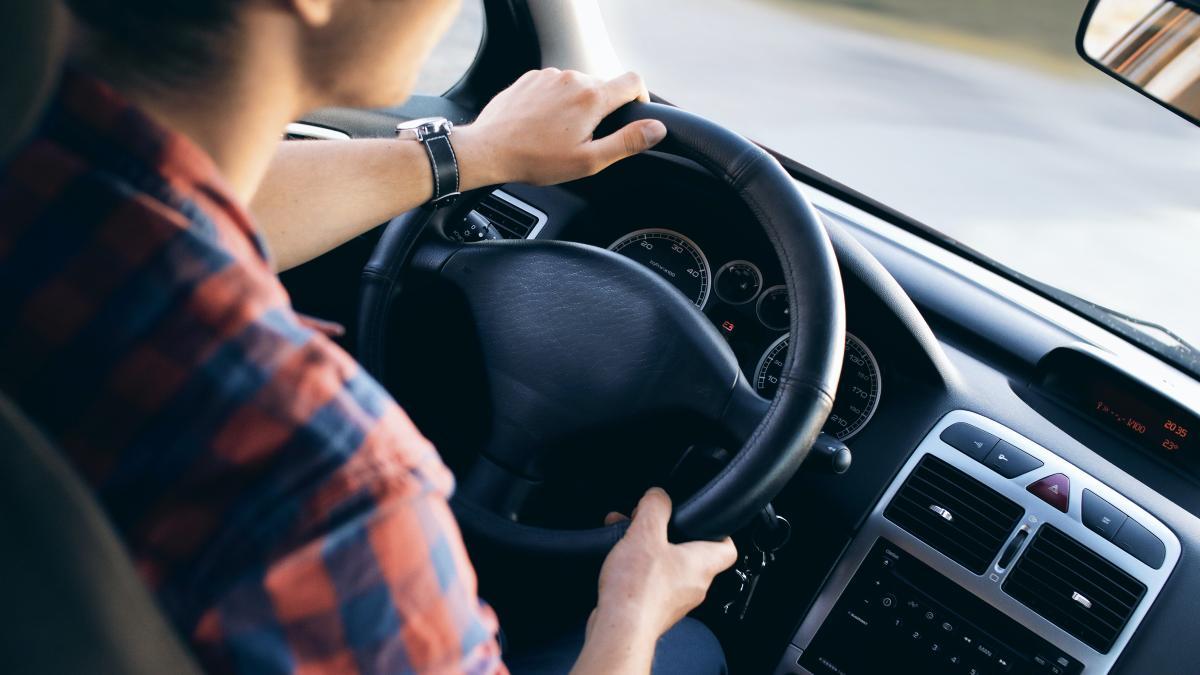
[{"xmin": 1039, "ymin": 350, "xmax": 1200, "ymax": 476}]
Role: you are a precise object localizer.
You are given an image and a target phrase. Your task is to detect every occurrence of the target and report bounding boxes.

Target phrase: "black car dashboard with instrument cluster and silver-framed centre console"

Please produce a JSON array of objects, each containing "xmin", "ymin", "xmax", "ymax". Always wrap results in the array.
[{"xmin": 286, "ymin": 112, "xmax": 1200, "ymax": 675}]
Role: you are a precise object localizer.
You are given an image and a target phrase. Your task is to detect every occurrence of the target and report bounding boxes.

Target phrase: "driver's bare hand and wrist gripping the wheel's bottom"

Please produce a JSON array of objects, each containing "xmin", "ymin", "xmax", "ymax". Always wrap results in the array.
[{"xmin": 571, "ymin": 488, "xmax": 738, "ymax": 675}]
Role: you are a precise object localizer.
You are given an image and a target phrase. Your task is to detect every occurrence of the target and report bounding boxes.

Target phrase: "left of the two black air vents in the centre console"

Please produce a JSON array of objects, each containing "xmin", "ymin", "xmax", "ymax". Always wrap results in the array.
[{"xmin": 883, "ymin": 455, "xmax": 1025, "ymax": 574}]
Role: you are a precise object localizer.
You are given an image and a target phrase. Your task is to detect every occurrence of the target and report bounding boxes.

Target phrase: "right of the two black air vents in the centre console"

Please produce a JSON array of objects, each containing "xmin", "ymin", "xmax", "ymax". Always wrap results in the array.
[{"xmin": 1004, "ymin": 525, "xmax": 1146, "ymax": 653}]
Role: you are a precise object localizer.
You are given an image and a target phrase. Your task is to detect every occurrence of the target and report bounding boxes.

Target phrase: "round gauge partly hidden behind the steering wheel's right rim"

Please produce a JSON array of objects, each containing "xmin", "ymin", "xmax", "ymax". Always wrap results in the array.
[{"xmin": 754, "ymin": 333, "xmax": 883, "ymax": 441}]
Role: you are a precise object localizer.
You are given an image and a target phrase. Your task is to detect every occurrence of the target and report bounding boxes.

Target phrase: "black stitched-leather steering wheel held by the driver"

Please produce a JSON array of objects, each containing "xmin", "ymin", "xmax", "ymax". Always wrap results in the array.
[{"xmin": 358, "ymin": 103, "xmax": 846, "ymax": 554}]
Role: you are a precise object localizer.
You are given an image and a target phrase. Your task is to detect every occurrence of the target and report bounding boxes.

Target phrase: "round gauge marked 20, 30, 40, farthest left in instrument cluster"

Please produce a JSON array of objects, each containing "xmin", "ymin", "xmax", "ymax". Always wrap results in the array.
[{"xmin": 608, "ymin": 228, "xmax": 713, "ymax": 309}]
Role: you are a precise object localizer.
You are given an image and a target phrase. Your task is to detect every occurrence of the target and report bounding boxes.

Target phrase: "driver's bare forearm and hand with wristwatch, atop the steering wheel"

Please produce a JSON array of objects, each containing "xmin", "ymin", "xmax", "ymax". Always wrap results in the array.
[{"xmin": 251, "ymin": 68, "xmax": 666, "ymax": 270}]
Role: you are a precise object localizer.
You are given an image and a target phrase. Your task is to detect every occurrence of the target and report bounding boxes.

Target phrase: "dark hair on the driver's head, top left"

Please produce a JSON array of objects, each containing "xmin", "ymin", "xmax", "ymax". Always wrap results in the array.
[{"xmin": 66, "ymin": 0, "xmax": 242, "ymax": 82}]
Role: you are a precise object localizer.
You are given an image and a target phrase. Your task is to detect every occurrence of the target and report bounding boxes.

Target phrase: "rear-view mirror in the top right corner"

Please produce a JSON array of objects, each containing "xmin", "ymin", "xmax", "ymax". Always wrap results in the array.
[{"xmin": 1075, "ymin": 0, "xmax": 1200, "ymax": 125}]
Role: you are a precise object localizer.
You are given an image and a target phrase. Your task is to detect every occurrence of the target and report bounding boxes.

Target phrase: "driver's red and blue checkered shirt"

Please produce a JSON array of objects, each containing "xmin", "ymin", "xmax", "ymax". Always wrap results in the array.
[{"xmin": 0, "ymin": 74, "xmax": 504, "ymax": 674}]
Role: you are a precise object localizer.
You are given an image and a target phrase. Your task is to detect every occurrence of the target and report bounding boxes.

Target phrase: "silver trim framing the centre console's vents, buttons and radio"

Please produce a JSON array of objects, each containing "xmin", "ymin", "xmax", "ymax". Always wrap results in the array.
[{"xmin": 776, "ymin": 411, "xmax": 1181, "ymax": 675}]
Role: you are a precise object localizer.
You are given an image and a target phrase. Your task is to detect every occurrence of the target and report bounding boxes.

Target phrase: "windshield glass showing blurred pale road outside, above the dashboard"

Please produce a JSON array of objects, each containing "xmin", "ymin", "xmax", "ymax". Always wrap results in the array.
[{"xmin": 601, "ymin": 0, "xmax": 1200, "ymax": 357}]
